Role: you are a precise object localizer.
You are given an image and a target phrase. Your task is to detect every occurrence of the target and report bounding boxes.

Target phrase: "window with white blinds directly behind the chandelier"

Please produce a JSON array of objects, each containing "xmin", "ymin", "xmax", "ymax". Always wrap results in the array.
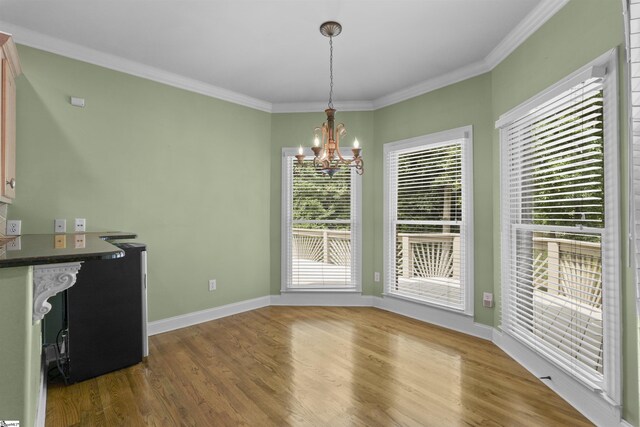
[{"xmin": 282, "ymin": 149, "xmax": 360, "ymax": 291}]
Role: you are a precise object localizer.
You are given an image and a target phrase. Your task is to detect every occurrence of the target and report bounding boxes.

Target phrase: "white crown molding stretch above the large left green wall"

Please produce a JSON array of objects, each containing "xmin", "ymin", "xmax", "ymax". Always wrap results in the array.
[{"xmin": 0, "ymin": 21, "xmax": 272, "ymax": 113}]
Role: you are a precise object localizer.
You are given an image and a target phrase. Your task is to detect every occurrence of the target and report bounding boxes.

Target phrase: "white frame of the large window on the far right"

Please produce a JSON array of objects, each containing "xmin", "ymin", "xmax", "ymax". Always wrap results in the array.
[{"xmin": 495, "ymin": 49, "xmax": 622, "ymax": 405}]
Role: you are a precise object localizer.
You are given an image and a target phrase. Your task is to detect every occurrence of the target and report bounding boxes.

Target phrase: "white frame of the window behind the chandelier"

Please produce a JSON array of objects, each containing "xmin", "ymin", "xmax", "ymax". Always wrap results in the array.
[{"xmin": 280, "ymin": 147, "xmax": 362, "ymax": 293}]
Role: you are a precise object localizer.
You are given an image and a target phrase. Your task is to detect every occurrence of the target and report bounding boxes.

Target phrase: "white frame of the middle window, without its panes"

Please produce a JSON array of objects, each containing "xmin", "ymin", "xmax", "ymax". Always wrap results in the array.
[{"xmin": 383, "ymin": 126, "xmax": 475, "ymax": 316}]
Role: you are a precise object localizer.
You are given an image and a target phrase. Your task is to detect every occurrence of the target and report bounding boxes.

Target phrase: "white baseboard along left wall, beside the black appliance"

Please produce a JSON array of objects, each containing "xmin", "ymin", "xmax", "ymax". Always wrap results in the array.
[{"xmin": 147, "ymin": 295, "xmax": 271, "ymax": 336}]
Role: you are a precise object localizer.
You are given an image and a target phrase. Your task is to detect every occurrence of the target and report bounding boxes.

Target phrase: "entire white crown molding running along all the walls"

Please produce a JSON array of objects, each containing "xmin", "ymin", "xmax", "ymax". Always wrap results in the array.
[{"xmin": 0, "ymin": 0, "xmax": 569, "ymax": 113}]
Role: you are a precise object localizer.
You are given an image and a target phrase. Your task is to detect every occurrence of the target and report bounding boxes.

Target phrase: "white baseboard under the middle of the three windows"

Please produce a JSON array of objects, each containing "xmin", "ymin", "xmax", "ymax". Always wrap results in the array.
[{"xmin": 371, "ymin": 296, "xmax": 493, "ymax": 340}]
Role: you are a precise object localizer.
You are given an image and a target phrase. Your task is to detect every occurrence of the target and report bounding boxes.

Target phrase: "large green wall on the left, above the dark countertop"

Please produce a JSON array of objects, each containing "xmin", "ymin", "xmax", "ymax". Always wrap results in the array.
[{"xmin": 9, "ymin": 46, "xmax": 271, "ymax": 321}]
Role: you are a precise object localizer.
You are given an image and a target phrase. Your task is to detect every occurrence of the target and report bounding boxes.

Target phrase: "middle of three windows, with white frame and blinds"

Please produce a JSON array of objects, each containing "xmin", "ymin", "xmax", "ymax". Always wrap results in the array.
[{"xmin": 384, "ymin": 127, "xmax": 473, "ymax": 314}]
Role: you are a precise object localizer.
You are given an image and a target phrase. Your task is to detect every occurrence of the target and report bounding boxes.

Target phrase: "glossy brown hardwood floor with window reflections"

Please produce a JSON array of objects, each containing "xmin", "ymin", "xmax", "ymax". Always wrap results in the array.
[{"xmin": 46, "ymin": 307, "xmax": 592, "ymax": 427}]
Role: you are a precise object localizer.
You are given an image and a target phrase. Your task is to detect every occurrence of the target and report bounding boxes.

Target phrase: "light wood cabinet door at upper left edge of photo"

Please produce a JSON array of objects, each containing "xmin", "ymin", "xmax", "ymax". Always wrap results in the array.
[{"xmin": 0, "ymin": 59, "xmax": 16, "ymax": 199}]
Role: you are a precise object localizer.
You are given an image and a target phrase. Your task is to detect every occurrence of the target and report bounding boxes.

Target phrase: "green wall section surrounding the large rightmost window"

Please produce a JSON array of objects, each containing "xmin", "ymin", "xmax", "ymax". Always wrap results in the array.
[{"xmin": 491, "ymin": 0, "xmax": 640, "ymax": 425}]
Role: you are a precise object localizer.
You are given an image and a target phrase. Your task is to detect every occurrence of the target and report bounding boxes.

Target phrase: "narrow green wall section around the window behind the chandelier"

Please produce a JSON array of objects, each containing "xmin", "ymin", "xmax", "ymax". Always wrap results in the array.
[{"xmin": 271, "ymin": 111, "xmax": 382, "ymax": 295}]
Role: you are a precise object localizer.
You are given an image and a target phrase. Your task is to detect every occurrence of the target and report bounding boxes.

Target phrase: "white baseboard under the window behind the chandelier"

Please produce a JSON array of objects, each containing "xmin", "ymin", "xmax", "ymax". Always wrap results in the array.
[{"xmin": 271, "ymin": 291, "xmax": 375, "ymax": 307}]
